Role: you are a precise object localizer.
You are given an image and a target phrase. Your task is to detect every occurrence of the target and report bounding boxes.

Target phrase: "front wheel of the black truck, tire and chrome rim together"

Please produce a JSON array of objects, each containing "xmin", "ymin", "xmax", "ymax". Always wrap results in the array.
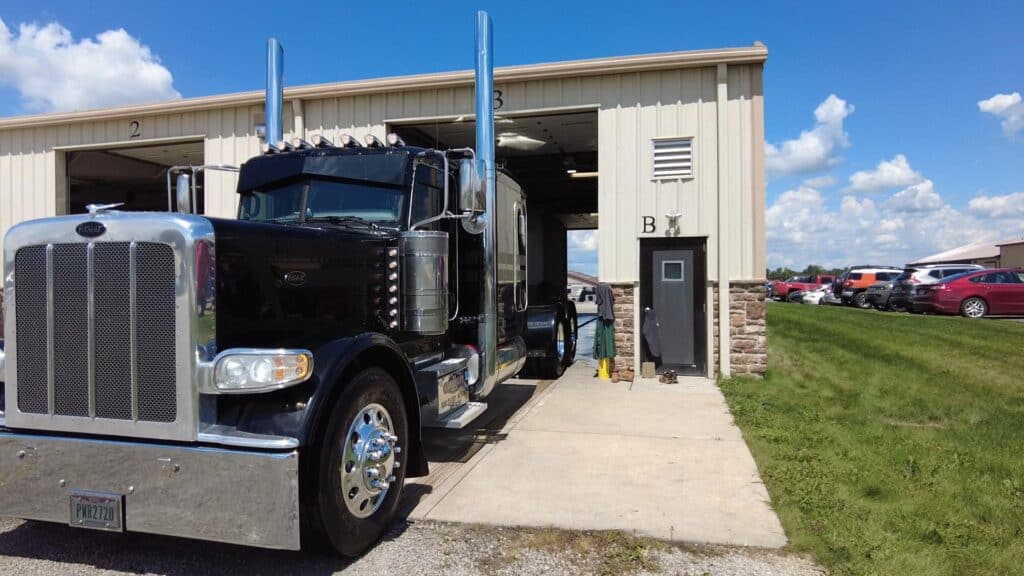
[{"xmin": 317, "ymin": 368, "xmax": 409, "ymax": 557}]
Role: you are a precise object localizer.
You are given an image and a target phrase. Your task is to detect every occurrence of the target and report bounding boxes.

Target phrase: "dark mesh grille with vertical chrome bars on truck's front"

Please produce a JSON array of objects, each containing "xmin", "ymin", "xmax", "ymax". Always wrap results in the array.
[{"xmin": 14, "ymin": 242, "xmax": 177, "ymax": 422}]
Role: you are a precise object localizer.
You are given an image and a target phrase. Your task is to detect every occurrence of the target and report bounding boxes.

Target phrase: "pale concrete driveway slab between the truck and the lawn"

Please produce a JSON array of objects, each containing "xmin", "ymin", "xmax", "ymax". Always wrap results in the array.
[{"xmin": 409, "ymin": 363, "xmax": 786, "ymax": 547}]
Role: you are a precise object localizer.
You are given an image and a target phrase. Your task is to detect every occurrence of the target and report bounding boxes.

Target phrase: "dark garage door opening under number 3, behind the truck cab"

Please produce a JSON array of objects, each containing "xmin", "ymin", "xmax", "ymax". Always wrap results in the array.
[{"xmin": 391, "ymin": 112, "xmax": 598, "ymax": 301}]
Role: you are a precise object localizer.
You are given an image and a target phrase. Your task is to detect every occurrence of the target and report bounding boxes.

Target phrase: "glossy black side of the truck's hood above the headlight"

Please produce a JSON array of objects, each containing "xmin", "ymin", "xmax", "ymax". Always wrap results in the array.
[{"xmin": 210, "ymin": 218, "xmax": 397, "ymax": 349}]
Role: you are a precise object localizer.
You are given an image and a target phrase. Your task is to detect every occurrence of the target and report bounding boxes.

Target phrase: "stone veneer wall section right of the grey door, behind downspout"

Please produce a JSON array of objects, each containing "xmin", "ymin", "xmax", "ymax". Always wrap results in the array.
[{"xmin": 711, "ymin": 280, "xmax": 768, "ymax": 376}]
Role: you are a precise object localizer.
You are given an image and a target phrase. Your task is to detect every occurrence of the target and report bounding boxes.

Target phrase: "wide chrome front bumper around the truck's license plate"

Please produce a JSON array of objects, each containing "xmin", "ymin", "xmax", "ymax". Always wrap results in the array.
[{"xmin": 0, "ymin": 431, "xmax": 299, "ymax": 550}]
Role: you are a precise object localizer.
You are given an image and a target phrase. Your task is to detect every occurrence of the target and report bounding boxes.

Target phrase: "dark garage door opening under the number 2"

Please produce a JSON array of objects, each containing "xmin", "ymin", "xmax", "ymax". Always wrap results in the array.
[{"xmin": 67, "ymin": 140, "xmax": 204, "ymax": 214}]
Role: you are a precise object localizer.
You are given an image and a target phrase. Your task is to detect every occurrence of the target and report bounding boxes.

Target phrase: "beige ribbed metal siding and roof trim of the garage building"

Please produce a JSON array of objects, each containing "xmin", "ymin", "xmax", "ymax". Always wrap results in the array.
[{"xmin": 0, "ymin": 64, "xmax": 764, "ymax": 282}]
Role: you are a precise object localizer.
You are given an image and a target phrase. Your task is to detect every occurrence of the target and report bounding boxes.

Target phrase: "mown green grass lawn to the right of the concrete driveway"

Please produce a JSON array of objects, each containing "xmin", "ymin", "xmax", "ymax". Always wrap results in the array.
[{"xmin": 722, "ymin": 303, "xmax": 1024, "ymax": 575}]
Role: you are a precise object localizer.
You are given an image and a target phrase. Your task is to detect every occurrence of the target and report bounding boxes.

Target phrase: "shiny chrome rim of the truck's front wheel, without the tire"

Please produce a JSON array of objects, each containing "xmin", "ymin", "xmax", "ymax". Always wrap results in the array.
[{"xmin": 338, "ymin": 404, "xmax": 400, "ymax": 518}]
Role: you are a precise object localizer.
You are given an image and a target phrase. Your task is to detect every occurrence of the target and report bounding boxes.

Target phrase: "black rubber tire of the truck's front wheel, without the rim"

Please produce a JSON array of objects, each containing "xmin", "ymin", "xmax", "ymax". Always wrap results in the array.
[{"xmin": 310, "ymin": 367, "xmax": 409, "ymax": 558}]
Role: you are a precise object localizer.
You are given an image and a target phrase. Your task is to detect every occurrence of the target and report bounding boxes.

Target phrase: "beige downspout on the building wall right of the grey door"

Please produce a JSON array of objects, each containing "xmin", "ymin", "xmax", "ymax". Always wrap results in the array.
[{"xmin": 715, "ymin": 64, "xmax": 732, "ymax": 378}]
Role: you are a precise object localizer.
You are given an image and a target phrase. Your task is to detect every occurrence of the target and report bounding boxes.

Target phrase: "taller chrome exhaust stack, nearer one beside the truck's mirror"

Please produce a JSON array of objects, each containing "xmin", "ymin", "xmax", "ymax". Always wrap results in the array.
[{"xmin": 474, "ymin": 10, "xmax": 498, "ymax": 397}]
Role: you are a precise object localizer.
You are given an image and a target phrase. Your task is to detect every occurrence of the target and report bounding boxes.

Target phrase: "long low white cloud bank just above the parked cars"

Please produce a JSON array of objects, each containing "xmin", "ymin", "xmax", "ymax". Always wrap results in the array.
[{"xmin": 766, "ymin": 179, "xmax": 1003, "ymax": 269}]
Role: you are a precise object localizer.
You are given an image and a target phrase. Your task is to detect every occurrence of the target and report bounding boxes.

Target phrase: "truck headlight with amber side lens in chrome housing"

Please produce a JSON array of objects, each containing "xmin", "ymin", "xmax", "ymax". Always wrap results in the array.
[{"xmin": 213, "ymin": 349, "xmax": 313, "ymax": 393}]
